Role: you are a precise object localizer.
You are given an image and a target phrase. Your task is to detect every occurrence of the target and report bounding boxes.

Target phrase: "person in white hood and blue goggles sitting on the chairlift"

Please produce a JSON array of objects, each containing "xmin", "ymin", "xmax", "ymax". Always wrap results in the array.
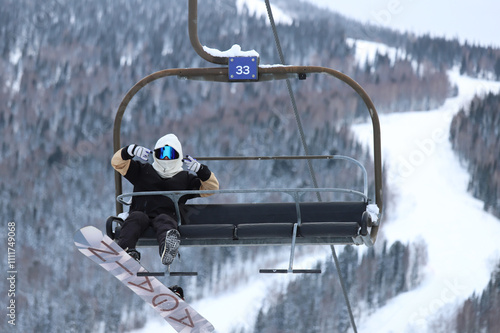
[{"xmin": 111, "ymin": 134, "xmax": 219, "ymax": 266}]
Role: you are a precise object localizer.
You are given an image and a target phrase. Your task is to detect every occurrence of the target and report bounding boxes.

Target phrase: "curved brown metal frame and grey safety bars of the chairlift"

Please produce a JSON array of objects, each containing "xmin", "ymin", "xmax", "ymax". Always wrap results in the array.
[{"xmin": 107, "ymin": 0, "xmax": 383, "ymax": 260}]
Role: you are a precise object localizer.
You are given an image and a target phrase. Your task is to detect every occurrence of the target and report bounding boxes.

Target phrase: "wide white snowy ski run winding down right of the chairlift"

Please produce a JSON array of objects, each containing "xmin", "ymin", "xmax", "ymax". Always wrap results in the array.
[{"xmin": 354, "ymin": 71, "xmax": 500, "ymax": 333}]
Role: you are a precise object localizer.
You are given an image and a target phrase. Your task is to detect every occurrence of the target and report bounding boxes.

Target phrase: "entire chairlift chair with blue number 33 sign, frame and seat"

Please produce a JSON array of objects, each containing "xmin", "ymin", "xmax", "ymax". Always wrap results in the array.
[{"xmin": 106, "ymin": 0, "xmax": 383, "ymax": 272}]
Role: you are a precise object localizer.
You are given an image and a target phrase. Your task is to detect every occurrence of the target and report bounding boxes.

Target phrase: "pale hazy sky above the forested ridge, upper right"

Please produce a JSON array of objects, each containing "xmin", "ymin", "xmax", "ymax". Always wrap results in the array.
[{"xmin": 302, "ymin": 0, "xmax": 500, "ymax": 47}]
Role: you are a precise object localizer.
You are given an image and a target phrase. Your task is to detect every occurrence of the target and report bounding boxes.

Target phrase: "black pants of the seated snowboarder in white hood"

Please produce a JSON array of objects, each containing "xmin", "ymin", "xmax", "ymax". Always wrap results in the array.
[{"xmin": 117, "ymin": 211, "xmax": 177, "ymax": 249}]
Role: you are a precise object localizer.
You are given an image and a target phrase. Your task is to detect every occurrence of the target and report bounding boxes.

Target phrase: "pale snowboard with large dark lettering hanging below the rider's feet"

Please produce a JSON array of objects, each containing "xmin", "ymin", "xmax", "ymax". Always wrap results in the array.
[{"xmin": 74, "ymin": 226, "xmax": 215, "ymax": 333}]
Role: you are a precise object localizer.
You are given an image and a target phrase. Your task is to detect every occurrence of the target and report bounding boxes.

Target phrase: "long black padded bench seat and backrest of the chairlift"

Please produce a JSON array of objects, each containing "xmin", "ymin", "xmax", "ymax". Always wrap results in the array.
[{"xmin": 106, "ymin": 201, "xmax": 367, "ymax": 246}]
